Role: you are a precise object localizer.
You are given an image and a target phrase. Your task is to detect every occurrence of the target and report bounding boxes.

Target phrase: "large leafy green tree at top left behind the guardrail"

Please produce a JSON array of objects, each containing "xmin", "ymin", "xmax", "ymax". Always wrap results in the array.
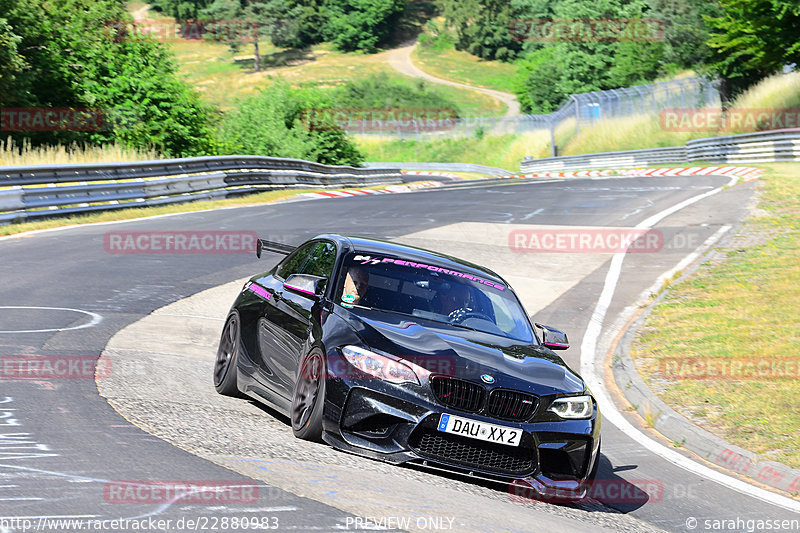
[{"xmin": 0, "ymin": 0, "xmax": 214, "ymax": 155}]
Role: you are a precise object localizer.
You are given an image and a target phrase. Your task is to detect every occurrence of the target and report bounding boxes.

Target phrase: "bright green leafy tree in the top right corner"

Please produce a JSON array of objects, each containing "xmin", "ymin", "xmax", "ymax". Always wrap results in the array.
[{"xmin": 706, "ymin": 0, "xmax": 800, "ymax": 95}]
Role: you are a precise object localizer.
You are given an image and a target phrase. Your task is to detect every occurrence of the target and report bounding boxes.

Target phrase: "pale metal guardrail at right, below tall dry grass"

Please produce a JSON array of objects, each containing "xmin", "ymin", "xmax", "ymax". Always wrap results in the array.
[{"xmin": 520, "ymin": 129, "xmax": 800, "ymax": 174}]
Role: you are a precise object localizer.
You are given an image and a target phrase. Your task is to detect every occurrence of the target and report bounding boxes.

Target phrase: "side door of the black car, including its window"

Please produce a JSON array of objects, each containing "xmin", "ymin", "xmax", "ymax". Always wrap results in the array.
[{"xmin": 259, "ymin": 241, "xmax": 336, "ymax": 399}]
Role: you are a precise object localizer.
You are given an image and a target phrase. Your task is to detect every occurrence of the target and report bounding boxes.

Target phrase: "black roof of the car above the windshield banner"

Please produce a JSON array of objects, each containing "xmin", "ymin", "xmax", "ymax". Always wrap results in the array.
[{"xmin": 314, "ymin": 234, "xmax": 508, "ymax": 285}]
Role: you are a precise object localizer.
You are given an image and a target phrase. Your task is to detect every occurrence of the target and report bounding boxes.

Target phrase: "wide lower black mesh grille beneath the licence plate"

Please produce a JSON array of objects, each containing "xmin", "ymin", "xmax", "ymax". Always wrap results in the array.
[{"xmin": 409, "ymin": 427, "xmax": 536, "ymax": 476}]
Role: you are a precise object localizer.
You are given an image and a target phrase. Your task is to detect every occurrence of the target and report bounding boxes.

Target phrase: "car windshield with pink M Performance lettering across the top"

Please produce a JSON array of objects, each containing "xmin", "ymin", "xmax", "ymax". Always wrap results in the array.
[{"xmin": 335, "ymin": 252, "xmax": 533, "ymax": 343}]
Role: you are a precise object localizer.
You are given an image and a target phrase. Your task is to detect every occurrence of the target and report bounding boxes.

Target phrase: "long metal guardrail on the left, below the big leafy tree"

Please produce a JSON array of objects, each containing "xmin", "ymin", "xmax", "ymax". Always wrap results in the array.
[{"xmin": 0, "ymin": 156, "xmax": 403, "ymax": 223}]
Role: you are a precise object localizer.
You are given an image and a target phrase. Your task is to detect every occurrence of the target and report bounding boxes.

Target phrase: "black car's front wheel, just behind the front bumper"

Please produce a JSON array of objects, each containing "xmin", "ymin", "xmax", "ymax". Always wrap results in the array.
[{"xmin": 289, "ymin": 352, "xmax": 327, "ymax": 441}]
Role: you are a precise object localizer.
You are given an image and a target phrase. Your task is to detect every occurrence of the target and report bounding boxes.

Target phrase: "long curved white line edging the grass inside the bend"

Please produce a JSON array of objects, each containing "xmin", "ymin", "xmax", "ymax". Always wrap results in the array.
[{"xmin": 581, "ymin": 177, "xmax": 800, "ymax": 512}]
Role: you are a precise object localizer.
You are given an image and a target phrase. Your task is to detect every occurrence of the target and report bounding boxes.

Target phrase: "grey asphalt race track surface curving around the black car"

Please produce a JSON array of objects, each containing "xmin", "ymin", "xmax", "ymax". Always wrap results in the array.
[{"xmin": 0, "ymin": 176, "xmax": 800, "ymax": 533}]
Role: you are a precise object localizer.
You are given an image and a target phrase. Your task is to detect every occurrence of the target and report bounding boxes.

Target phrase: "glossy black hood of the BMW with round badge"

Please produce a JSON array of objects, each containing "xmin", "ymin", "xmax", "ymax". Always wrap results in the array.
[{"xmin": 337, "ymin": 310, "xmax": 586, "ymax": 396}]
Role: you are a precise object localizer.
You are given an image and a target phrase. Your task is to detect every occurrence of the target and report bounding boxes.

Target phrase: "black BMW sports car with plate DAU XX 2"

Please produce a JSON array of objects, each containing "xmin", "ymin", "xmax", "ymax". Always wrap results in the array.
[{"xmin": 214, "ymin": 235, "xmax": 600, "ymax": 499}]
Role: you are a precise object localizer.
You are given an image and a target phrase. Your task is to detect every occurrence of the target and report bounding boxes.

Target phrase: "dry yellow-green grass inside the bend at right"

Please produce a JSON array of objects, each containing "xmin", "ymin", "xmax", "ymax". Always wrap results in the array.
[{"xmin": 631, "ymin": 163, "xmax": 800, "ymax": 468}]
